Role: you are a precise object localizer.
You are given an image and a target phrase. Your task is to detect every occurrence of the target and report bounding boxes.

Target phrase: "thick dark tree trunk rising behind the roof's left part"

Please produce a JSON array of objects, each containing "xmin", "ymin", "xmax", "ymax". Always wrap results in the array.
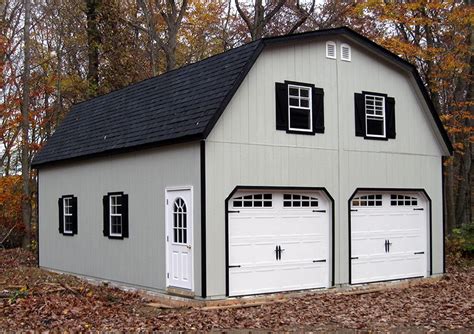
[{"xmin": 86, "ymin": 0, "xmax": 102, "ymax": 97}]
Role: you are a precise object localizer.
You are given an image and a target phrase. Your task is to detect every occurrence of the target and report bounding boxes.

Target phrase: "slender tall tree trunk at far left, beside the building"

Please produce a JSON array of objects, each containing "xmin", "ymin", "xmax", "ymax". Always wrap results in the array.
[{"xmin": 21, "ymin": 0, "xmax": 31, "ymax": 248}]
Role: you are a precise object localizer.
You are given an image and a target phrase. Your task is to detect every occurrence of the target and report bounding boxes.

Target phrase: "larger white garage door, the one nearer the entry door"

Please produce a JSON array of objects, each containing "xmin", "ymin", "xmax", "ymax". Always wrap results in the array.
[{"xmin": 228, "ymin": 191, "xmax": 330, "ymax": 296}]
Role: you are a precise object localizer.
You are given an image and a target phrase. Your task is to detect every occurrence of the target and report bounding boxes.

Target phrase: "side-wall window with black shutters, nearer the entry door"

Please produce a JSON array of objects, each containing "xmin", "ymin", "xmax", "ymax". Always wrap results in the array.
[{"xmin": 103, "ymin": 192, "xmax": 128, "ymax": 239}]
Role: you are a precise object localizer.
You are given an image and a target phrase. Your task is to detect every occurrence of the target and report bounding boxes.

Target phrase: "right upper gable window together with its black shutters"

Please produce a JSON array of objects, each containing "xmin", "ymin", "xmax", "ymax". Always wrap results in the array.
[{"xmin": 354, "ymin": 92, "xmax": 396, "ymax": 140}]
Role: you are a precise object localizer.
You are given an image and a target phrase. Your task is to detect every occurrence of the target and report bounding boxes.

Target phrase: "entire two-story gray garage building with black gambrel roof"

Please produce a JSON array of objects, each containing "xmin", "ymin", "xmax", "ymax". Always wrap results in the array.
[{"xmin": 33, "ymin": 28, "xmax": 452, "ymax": 299}]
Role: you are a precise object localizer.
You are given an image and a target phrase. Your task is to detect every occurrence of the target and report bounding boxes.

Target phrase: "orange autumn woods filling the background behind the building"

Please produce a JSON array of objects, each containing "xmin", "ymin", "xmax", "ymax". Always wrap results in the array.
[{"xmin": 0, "ymin": 0, "xmax": 474, "ymax": 247}]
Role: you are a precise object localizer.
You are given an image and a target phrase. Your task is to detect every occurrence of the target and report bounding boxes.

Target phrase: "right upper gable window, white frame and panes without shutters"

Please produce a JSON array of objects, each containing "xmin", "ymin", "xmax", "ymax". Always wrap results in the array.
[{"xmin": 365, "ymin": 95, "xmax": 385, "ymax": 138}]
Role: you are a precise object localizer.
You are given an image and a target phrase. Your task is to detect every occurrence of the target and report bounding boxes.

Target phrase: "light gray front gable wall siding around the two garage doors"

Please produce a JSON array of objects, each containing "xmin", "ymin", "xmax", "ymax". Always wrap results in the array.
[{"xmin": 206, "ymin": 40, "xmax": 445, "ymax": 296}]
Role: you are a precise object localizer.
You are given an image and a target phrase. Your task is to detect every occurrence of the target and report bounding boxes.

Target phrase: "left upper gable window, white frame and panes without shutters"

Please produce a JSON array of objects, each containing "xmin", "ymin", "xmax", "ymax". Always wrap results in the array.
[{"xmin": 288, "ymin": 85, "xmax": 313, "ymax": 132}]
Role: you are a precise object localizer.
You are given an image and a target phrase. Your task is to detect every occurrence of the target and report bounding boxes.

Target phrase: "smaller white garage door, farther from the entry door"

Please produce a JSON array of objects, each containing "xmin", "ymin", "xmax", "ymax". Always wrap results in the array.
[{"xmin": 350, "ymin": 192, "xmax": 429, "ymax": 284}]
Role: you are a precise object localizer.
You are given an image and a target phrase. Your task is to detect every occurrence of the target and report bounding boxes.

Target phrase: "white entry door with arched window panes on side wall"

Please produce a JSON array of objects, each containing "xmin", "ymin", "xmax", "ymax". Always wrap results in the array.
[{"xmin": 166, "ymin": 189, "xmax": 193, "ymax": 290}]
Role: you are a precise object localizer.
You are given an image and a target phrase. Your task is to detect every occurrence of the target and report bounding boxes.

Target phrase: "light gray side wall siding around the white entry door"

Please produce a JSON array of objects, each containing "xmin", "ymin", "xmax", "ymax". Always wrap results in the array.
[{"xmin": 39, "ymin": 143, "xmax": 201, "ymax": 294}]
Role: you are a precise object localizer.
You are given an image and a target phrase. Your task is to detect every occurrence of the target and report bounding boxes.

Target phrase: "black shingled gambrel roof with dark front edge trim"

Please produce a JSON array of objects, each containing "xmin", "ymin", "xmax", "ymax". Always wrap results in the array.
[{"xmin": 33, "ymin": 27, "xmax": 452, "ymax": 167}]
